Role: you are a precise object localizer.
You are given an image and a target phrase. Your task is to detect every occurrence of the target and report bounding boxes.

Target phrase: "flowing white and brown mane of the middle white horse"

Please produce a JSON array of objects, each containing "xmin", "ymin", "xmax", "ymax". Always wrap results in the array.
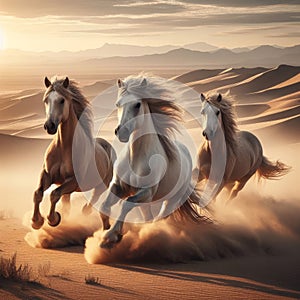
[{"xmin": 121, "ymin": 73, "xmax": 183, "ymax": 160}]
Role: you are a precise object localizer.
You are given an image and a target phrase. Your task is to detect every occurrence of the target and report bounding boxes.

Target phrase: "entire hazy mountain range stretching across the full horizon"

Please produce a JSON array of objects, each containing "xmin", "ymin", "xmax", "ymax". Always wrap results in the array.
[{"xmin": 0, "ymin": 42, "xmax": 300, "ymax": 71}]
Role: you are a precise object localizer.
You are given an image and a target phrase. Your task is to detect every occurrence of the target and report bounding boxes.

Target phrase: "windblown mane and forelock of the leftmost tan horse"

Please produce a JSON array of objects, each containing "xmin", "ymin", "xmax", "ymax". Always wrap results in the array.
[{"xmin": 44, "ymin": 77, "xmax": 94, "ymax": 139}]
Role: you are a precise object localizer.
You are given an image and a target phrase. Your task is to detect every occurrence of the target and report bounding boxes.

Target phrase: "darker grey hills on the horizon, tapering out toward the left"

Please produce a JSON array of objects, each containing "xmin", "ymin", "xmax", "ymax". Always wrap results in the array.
[{"xmin": 81, "ymin": 45, "xmax": 300, "ymax": 68}]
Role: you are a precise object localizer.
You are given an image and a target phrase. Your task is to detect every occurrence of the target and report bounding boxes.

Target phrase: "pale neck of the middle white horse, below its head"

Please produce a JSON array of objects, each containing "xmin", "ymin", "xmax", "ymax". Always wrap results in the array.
[{"xmin": 129, "ymin": 106, "xmax": 160, "ymax": 159}]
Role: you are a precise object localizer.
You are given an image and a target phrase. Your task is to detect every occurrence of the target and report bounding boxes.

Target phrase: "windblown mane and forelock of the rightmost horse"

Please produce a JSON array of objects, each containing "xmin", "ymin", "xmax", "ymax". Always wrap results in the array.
[{"xmin": 207, "ymin": 93, "xmax": 238, "ymax": 153}]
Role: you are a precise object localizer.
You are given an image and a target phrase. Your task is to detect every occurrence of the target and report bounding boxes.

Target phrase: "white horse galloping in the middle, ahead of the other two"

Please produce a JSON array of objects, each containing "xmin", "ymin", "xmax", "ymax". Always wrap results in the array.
[{"xmin": 99, "ymin": 74, "xmax": 204, "ymax": 248}]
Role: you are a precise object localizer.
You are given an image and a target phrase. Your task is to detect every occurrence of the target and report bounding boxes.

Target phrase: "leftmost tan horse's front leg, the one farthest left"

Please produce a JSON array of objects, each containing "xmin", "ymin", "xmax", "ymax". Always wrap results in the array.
[{"xmin": 31, "ymin": 170, "xmax": 51, "ymax": 229}]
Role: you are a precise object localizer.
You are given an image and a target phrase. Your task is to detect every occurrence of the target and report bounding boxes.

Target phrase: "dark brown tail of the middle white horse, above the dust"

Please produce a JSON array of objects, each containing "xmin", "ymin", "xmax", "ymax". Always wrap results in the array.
[{"xmin": 173, "ymin": 189, "xmax": 213, "ymax": 224}]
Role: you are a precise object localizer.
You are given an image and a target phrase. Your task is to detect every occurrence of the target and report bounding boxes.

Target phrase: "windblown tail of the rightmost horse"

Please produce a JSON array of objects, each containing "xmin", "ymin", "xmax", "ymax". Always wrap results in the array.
[{"xmin": 257, "ymin": 156, "xmax": 291, "ymax": 179}]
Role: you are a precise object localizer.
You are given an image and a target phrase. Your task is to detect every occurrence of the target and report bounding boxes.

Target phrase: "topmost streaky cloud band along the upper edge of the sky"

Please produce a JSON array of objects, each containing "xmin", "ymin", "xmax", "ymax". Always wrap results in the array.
[{"xmin": 0, "ymin": 0, "xmax": 300, "ymax": 18}]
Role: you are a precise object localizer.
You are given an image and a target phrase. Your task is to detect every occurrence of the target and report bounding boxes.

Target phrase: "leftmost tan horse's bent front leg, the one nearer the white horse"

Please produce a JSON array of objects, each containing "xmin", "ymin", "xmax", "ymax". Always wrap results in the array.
[{"xmin": 47, "ymin": 177, "xmax": 78, "ymax": 227}]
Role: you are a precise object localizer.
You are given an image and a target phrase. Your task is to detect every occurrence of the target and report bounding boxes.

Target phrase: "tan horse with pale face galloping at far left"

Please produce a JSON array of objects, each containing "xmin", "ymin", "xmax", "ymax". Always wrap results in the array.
[{"xmin": 31, "ymin": 77, "xmax": 116, "ymax": 229}]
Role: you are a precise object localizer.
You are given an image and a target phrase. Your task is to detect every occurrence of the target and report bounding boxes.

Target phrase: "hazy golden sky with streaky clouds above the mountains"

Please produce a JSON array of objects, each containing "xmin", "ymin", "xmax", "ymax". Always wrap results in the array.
[{"xmin": 0, "ymin": 0, "xmax": 300, "ymax": 51}]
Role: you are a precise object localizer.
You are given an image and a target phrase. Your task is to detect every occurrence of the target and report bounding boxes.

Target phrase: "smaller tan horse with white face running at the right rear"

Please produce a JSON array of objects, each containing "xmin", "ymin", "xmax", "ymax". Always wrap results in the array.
[{"xmin": 193, "ymin": 93, "xmax": 290, "ymax": 203}]
